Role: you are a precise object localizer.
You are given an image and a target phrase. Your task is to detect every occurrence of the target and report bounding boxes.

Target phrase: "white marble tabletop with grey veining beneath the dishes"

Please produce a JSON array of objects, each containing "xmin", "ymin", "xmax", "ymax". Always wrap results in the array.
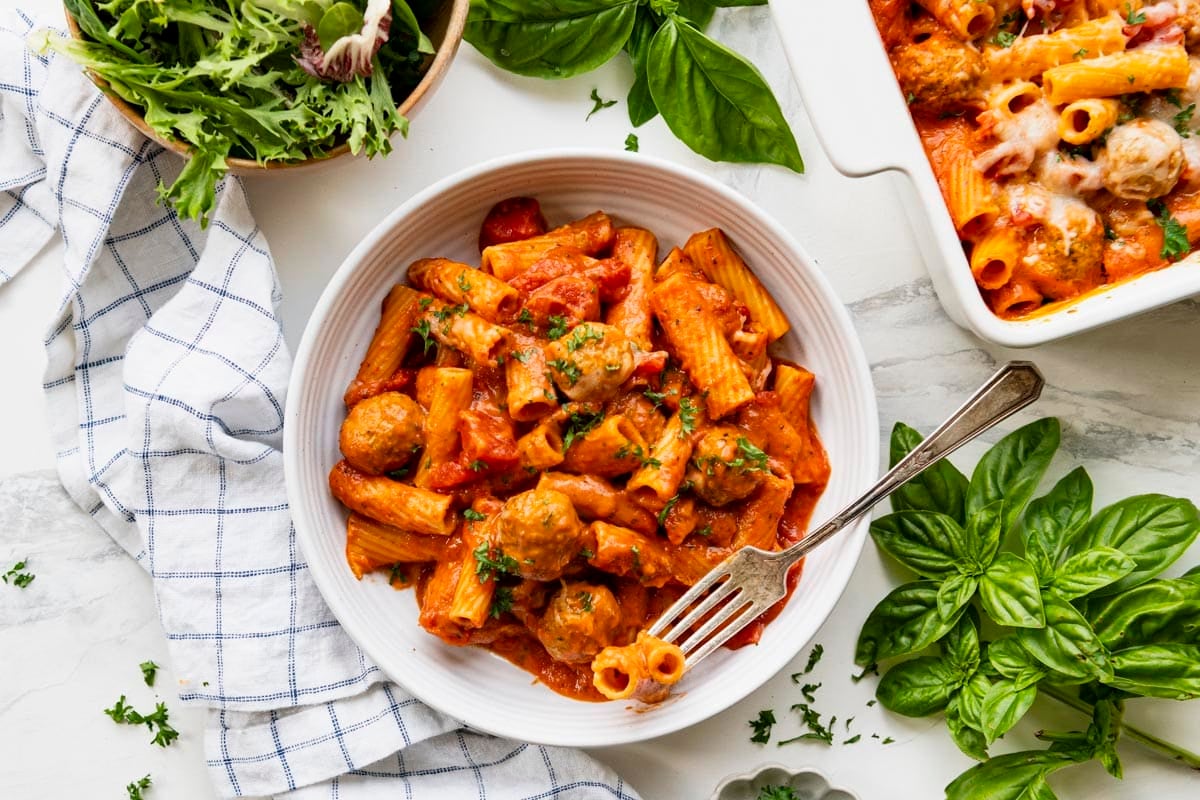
[{"xmin": 0, "ymin": 0, "xmax": 1200, "ymax": 800}]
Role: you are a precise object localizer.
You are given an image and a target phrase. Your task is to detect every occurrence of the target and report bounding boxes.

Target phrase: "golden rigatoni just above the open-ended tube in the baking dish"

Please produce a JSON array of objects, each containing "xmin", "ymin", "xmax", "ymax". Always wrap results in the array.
[{"xmin": 1042, "ymin": 44, "xmax": 1190, "ymax": 106}]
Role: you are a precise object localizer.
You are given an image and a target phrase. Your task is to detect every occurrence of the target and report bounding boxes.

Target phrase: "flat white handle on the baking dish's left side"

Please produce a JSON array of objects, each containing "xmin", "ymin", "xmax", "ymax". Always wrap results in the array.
[{"xmin": 770, "ymin": 0, "xmax": 923, "ymax": 178}]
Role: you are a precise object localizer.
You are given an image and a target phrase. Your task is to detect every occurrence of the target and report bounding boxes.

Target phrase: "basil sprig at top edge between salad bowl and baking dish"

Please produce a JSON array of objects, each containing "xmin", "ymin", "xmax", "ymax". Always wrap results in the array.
[{"xmin": 463, "ymin": 0, "xmax": 804, "ymax": 173}]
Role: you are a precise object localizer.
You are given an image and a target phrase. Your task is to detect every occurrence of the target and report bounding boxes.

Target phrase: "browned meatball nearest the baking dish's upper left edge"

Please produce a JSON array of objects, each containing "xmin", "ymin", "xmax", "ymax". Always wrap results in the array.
[{"xmin": 890, "ymin": 32, "xmax": 984, "ymax": 113}]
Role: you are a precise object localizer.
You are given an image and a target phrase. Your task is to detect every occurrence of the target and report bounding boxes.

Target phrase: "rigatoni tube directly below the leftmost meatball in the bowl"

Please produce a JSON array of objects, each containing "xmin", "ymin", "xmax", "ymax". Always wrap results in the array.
[{"xmin": 329, "ymin": 461, "xmax": 455, "ymax": 536}]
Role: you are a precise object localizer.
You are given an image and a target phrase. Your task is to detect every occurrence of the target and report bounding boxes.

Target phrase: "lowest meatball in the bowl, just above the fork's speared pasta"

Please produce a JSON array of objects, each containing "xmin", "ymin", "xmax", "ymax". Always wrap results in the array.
[{"xmin": 538, "ymin": 582, "xmax": 620, "ymax": 662}]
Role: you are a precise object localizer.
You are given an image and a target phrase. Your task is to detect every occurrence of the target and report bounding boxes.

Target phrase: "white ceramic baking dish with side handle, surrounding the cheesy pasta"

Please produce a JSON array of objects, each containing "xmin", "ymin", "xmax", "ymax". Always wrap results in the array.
[{"xmin": 770, "ymin": 0, "xmax": 1200, "ymax": 347}]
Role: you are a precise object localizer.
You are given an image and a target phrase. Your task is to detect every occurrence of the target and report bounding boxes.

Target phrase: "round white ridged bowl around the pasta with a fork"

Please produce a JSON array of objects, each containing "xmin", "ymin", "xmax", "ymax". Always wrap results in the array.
[{"xmin": 283, "ymin": 151, "xmax": 878, "ymax": 746}]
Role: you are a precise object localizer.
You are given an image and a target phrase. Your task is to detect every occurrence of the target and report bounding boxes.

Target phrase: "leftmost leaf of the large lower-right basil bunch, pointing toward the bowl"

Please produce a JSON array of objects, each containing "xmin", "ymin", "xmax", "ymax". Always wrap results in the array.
[{"xmin": 854, "ymin": 581, "xmax": 959, "ymax": 667}]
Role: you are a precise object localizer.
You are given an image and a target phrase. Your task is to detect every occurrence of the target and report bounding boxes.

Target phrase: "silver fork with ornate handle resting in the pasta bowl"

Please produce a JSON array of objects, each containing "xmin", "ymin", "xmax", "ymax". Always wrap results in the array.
[{"xmin": 648, "ymin": 361, "xmax": 1044, "ymax": 669}]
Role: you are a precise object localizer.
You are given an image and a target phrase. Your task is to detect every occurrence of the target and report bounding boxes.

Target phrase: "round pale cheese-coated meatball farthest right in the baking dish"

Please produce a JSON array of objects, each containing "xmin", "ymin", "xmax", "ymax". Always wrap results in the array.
[{"xmin": 1099, "ymin": 119, "xmax": 1184, "ymax": 200}]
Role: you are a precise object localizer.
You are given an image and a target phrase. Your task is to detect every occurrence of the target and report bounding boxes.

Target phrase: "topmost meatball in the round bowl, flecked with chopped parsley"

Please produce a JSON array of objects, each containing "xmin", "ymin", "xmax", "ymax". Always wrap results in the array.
[{"xmin": 546, "ymin": 323, "xmax": 634, "ymax": 402}]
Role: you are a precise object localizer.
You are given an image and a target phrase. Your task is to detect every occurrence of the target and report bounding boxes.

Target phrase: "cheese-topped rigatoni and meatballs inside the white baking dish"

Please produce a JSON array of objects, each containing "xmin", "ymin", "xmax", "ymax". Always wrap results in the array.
[{"xmin": 869, "ymin": 0, "xmax": 1200, "ymax": 318}]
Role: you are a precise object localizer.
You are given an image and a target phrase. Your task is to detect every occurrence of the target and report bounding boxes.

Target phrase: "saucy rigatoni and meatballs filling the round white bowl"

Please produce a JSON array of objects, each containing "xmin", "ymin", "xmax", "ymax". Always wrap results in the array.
[{"xmin": 329, "ymin": 198, "xmax": 829, "ymax": 703}]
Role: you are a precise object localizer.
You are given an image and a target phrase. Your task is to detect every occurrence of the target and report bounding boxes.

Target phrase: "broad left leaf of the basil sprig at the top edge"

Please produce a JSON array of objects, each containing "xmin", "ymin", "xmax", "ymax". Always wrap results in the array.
[{"xmin": 463, "ymin": 0, "xmax": 638, "ymax": 78}]
